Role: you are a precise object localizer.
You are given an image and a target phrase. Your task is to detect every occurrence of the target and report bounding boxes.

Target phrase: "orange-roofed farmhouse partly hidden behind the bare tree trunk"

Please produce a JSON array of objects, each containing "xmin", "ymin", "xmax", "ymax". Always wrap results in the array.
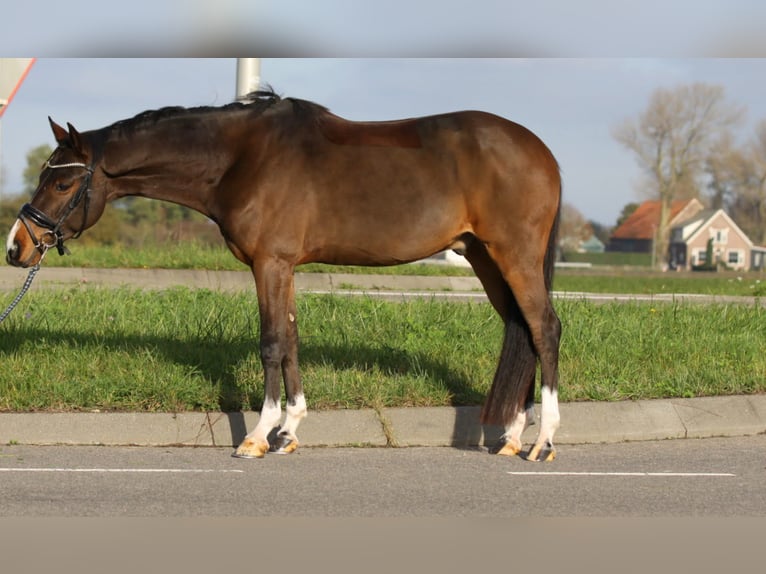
[{"xmin": 606, "ymin": 199, "xmax": 705, "ymax": 253}]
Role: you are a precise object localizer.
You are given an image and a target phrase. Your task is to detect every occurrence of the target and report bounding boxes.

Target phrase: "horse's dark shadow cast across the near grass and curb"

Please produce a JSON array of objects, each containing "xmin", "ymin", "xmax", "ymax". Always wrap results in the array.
[{"xmin": 0, "ymin": 328, "xmax": 500, "ymax": 447}]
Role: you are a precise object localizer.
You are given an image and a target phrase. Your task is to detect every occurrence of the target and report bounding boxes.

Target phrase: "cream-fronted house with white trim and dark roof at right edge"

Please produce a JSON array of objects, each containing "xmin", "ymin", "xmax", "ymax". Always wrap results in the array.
[{"xmin": 669, "ymin": 209, "xmax": 766, "ymax": 271}]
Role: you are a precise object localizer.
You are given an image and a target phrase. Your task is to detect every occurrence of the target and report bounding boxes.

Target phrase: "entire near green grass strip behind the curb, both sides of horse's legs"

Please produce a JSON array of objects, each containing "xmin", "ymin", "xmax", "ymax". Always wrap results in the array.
[{"xmin": 0, "ymin": 285, "xmax": 766, "ymax": 412}]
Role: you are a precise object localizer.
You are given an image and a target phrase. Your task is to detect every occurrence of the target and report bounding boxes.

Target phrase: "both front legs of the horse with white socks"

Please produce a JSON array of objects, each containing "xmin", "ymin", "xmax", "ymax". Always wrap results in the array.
[{"xmin": 234, "ymin": 258, "xmax": 306, "ymax": 458}]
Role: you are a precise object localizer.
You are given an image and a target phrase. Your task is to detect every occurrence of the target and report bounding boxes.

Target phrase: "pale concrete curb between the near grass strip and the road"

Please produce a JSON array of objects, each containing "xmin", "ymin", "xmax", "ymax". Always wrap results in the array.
[{"xmin": 0, "ymin": 395, "xmax": 766, "ymax": 447}]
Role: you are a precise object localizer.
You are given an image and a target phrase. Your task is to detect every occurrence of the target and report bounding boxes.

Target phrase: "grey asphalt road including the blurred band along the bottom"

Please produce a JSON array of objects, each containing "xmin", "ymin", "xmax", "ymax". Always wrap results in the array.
[{"xmin": 0, "ymin": 435, "xmax": 766, "ymax": 574}]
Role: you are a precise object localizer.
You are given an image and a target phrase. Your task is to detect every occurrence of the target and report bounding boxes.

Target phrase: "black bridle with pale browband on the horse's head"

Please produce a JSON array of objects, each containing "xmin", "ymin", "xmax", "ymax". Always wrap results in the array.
[{"xmin": 18, "ymin": 161, "xmax": 93, "ymax": 255}]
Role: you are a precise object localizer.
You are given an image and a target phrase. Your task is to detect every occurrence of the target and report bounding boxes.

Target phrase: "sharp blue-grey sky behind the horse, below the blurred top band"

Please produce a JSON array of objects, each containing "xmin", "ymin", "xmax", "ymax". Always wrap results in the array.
[{"xmin": 0, "ymin": 58, "xmax": 766, "ymax": 226}]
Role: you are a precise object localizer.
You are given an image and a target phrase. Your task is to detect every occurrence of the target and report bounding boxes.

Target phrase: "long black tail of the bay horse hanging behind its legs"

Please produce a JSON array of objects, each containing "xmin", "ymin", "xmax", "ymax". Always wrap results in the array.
[{"xmin": 481, "ymin": 202, "xmax": 561, "ymax": 426}]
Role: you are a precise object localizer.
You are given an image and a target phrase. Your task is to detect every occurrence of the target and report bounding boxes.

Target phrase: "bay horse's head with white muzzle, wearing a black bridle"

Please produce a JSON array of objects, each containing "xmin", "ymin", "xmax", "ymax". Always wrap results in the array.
[{"xmin": 5, "ymin": 118, "xmax": 106, "ymax": 267}]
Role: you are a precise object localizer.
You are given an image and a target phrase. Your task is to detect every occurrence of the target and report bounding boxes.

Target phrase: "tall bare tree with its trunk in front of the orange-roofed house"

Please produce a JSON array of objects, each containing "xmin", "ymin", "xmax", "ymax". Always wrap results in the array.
[{"xmin": 613, "ymin": 83, "xmax": 744, "ymax": 268}]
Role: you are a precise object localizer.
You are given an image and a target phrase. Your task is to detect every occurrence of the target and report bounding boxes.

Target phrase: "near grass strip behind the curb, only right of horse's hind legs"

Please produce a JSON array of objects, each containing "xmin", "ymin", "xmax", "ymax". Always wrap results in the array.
[{"xmin": 558, "ymin": 301, "xmax": 766, "ymax": 401}]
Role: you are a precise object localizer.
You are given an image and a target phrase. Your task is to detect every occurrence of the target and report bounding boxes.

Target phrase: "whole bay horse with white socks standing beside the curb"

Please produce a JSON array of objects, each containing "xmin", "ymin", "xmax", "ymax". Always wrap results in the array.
[{"xmin": 6, "ymin": 93, "xmax": 561, "ymax": 461}]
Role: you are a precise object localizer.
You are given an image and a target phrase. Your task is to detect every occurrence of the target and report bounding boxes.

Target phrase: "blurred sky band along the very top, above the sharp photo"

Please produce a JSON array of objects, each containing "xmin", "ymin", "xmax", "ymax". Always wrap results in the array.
[{"xmin": 0, "ymin": 0, "xmax": 766, "ymax": 57}]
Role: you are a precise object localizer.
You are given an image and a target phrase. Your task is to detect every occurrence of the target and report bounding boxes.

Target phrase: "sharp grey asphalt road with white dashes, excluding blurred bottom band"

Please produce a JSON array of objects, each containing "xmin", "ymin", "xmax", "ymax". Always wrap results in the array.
[{"xmin": 0, "ymin": 435, "xmax": 766, "ymax": 518}]
